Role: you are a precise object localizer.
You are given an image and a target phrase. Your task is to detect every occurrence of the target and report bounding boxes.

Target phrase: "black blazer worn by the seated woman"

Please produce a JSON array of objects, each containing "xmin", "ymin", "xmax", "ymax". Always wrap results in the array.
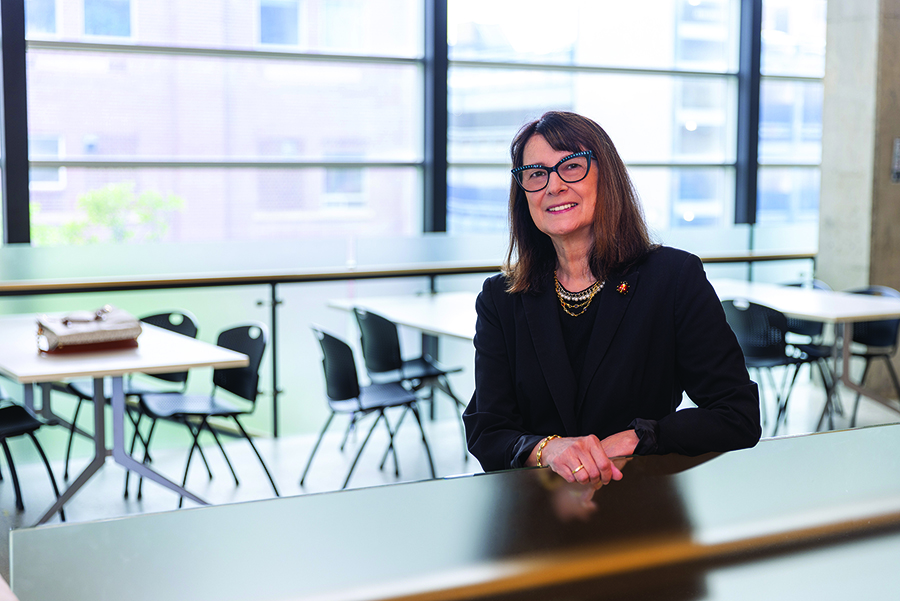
[{"xmin": 463, "ymin": 247, "xmax": 761, "ymax": 471}]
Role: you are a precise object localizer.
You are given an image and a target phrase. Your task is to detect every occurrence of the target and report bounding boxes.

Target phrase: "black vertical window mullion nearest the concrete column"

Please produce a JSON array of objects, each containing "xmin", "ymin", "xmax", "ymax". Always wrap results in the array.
[{"xmin": 734, "ymin": 0, "xmax": 762, "ymax": 224}]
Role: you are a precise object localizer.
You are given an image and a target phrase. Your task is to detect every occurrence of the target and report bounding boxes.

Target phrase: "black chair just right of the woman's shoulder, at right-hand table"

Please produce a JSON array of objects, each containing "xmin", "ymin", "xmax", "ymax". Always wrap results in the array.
[{"xmin": 722, "ymin": 299, "xmax": 802, "ymax": 436}]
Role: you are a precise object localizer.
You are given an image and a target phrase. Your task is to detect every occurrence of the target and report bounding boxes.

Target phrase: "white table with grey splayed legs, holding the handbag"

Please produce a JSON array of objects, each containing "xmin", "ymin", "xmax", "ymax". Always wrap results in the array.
[{"xmin": 0, "ymin": 315, "xmax": 248, "ymax": 524}]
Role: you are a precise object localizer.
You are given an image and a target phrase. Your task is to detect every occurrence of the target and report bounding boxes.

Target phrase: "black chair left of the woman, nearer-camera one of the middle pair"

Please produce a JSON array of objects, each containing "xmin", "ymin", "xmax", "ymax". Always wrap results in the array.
[{"xmin": 300, "ymin": 327, "xmax": 436, "ymax": 488}]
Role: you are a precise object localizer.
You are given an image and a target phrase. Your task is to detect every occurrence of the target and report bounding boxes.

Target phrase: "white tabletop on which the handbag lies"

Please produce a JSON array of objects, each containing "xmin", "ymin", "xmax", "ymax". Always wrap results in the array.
[{"xmin": 0, "ymin": 315, "xmax": 247, "ymax": 384}]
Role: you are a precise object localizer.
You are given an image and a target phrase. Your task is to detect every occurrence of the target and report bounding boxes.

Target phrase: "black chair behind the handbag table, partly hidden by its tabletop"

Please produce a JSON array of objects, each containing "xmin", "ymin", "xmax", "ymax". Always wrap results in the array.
[{"xmin": 59, "ymin": 311, "xmax": 205, "ymax": 478}]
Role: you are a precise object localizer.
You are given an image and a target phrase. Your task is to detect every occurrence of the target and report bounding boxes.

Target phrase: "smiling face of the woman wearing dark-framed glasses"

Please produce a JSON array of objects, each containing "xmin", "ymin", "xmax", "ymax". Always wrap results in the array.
[{"xmin": 523, "ymin": 134, "xmax": 597, "ymax": 244}]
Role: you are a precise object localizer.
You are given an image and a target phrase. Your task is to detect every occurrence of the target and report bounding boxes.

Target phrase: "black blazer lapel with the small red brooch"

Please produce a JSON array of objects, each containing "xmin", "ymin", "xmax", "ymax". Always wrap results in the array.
[{"xmin": 575, "ymin": 270, "xmax": 640, "ymax": 412}]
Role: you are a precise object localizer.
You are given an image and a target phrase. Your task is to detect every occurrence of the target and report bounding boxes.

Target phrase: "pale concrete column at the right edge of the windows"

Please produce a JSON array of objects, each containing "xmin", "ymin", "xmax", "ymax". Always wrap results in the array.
[{"xmin": 817, "ymin": 0, "xmax": 900, "ymax": 396}]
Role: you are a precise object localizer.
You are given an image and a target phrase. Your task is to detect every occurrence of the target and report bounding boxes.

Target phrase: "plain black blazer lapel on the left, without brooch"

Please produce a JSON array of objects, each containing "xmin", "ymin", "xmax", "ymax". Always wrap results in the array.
[{"xmin": 522, "ymin": 286, "xmax": 577, "ymax": 436}]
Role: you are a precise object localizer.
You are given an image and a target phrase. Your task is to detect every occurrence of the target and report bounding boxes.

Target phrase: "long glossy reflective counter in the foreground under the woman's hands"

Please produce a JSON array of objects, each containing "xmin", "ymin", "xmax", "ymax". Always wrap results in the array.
[{"xmin": 11, "ymin": 425, "xmax": 900, "ymax": 601}]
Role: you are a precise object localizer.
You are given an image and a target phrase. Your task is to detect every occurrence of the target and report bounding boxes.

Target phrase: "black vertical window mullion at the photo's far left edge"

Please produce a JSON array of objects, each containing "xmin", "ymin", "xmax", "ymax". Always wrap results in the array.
[{"xmin": 0, "ymin": 0, "xmax": 31, "ymax": 244}]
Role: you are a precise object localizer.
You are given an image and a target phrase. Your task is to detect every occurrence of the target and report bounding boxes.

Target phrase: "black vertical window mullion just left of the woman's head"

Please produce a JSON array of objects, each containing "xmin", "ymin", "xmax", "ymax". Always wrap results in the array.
[{"xmin": 423, "ymin": 0, "xmax": 448, "ymax": 232}]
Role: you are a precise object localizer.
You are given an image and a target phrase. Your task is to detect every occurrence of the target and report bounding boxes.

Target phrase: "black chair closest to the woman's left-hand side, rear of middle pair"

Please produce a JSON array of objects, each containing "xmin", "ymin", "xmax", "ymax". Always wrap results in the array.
[{"xmin": 353, "ymin": 307, "xmax": 469, "ymax": 461}]
